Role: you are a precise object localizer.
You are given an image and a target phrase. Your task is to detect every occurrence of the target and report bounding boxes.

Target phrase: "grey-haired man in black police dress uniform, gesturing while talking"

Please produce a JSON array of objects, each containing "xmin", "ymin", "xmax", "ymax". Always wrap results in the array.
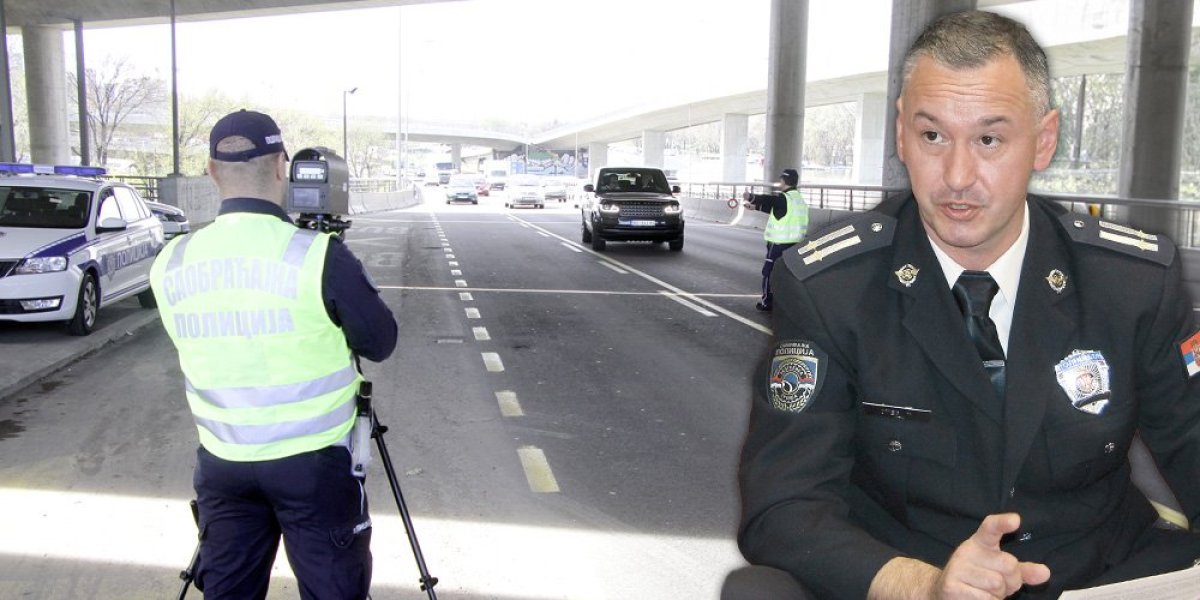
[{"xmin": 725, "ymin": 12, "xmax": 1200, "ymax": 599}]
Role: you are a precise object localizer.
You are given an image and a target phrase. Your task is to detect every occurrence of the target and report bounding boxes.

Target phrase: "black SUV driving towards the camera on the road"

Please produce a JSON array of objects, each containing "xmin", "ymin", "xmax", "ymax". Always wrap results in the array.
[{"xmin": 582, "ymin": 167, "xmax": 683, "ymax": 252}]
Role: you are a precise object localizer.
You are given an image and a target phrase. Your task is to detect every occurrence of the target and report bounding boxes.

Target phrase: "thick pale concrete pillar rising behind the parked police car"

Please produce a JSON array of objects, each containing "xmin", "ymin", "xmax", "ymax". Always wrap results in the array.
[{"xmin": 20, "ymin": 25, "xmax": 71, "ymax": 164}]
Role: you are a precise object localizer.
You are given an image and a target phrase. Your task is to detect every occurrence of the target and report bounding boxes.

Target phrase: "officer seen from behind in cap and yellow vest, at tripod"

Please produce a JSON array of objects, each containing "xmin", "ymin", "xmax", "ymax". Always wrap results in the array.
[{"xmin": 151, "ymin": 110, "xmax": 397, "ymax": 600}]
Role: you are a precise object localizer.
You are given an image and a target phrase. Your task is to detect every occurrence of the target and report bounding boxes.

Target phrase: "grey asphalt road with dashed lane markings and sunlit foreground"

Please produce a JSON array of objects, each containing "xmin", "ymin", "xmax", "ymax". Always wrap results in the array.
[{"xmin": 0, "ymin": 187, "xmax": 769, "ymax": 600}]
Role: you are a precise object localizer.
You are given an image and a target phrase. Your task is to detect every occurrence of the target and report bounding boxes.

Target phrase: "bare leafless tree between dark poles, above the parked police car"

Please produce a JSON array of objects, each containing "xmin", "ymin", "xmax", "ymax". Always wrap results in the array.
[{"xmin": 71, "ymin": 56, "xmax": 166, "ymax": 166}]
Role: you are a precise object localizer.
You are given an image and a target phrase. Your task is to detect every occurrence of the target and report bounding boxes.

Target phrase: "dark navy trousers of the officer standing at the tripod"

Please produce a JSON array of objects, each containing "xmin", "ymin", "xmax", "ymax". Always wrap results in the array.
[{"xmin": 193, "ymin": 446, "xmax": 371, "ymax": 600}]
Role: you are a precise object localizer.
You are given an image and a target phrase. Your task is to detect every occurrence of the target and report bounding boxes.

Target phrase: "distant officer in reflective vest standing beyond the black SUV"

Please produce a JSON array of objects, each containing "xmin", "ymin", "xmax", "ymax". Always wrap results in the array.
[{"xmin": 743, "ymin": 169, "xmax": 809, "ymax": 311}]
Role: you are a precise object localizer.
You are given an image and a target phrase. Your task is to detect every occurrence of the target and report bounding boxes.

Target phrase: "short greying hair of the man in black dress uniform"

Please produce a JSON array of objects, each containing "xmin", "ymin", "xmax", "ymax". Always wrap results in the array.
[{"xmin": 902, "ymin": 11, "xmax": 1050, "ymax": 115}]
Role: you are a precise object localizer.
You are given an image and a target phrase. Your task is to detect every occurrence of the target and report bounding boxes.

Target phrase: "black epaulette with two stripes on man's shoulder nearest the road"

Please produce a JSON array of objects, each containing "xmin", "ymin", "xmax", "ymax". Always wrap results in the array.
[{"xmin": 784, "ymin": 211, "xmax": 896, "ymax": 280}]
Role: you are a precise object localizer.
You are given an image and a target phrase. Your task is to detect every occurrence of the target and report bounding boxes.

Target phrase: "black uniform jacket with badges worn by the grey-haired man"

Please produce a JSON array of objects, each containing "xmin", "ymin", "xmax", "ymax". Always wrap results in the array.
[{"xmin": 739, "ymin": 196, "xmax": 1200, "ymax": 599}]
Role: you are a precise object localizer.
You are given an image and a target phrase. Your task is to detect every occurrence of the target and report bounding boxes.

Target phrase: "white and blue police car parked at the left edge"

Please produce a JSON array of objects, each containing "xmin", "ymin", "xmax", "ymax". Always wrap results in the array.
[{"xmin": 0, "ymin": 163, "xmax": 163, "ymax": 336}]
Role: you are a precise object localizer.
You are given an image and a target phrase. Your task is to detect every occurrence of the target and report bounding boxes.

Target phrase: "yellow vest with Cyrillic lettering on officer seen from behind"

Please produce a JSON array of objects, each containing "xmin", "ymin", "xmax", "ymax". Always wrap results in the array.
[{"xmin": 150, "ymin": 212, "xmax": 362, "ymax": 462}]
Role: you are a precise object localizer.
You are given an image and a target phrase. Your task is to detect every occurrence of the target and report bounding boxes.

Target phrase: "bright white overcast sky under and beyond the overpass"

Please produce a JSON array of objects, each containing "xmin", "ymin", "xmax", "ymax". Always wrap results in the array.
[{"xmin": 58, "ymin": 0, "xmax": 892, "ymax": 132}]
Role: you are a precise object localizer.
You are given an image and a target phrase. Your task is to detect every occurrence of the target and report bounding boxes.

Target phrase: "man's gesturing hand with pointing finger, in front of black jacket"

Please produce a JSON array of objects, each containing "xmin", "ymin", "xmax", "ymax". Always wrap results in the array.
[{"xmin": 935, "ymin": 512, "xmax": 1050, "ymax": 600}]
